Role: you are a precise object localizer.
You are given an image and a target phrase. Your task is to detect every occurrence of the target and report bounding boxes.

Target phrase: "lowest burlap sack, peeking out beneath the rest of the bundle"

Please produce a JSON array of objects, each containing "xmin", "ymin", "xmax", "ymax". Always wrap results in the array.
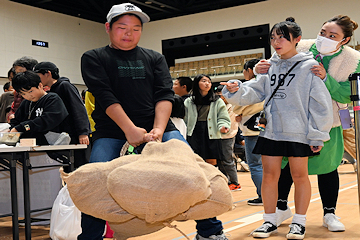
[{"xmin": 109, "ymin": 217, "xmax": 165, "ymax": 240}]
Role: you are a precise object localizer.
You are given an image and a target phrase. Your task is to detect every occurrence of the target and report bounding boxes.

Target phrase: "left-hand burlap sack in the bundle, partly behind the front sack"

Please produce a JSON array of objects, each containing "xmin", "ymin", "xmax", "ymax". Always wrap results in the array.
[{"xmin": 60, "ymin": 155, "xmax": 140, "ymax": 222}]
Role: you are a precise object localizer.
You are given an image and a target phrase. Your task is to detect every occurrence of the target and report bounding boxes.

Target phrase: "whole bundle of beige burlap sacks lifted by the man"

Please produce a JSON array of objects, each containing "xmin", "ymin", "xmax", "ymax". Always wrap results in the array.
[{"xmin": 62, "ymin": 140, "xmax": 232, "ymax": 240}]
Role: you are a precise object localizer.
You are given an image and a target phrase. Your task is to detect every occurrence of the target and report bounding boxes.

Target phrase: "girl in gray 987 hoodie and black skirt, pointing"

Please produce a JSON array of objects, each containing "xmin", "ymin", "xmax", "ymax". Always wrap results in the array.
[{"xmin": 222, "ymin": 18, "xmax": 332, "ymax": 239}]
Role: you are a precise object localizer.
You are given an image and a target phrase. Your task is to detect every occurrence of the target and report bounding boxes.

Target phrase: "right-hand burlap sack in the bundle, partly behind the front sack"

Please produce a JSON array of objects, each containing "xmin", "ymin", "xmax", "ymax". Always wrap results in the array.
[{"xmin": 174, "ymin": 156, "xmax": 233, "ymax": 221}]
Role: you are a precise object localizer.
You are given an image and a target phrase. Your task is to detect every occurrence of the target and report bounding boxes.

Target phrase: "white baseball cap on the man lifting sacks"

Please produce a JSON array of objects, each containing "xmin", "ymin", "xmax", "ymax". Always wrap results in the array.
[{"xmin": 106, "ymin": 3, "xmax": 150, "ymax": 23}]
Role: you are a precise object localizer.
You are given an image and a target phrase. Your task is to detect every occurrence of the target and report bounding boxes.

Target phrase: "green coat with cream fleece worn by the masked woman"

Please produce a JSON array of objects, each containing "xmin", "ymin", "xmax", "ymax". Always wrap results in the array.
[{"xmin": 282, "ymin": 40, "xmax": 360, "ymax": 175}]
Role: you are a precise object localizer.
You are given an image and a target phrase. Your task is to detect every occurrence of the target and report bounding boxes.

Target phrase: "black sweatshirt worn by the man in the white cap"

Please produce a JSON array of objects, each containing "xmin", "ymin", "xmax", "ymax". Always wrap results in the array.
[{"xmin": 81, "ymin": 46, "xmax": 176, "ymax": 140}]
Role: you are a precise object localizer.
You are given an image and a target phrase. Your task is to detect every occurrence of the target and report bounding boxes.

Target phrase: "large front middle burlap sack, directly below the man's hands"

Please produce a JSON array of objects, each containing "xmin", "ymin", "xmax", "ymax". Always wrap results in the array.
[{"xmin": 107, "ymin": 139, "xmax": 211, "ymax": 223}]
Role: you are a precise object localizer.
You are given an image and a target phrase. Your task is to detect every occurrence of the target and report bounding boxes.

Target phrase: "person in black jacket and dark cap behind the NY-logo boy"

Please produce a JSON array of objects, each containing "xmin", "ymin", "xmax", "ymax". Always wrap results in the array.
[{"xmin": 34, "ymin": 62, "xmax": 90, "ymax": 168}]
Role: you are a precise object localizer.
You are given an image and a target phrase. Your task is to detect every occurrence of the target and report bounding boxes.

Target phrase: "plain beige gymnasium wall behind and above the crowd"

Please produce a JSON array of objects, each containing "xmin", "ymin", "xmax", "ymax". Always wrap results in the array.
[{"xmin": 0, "ymin": 0, "xmax": 360, "ymax": 88}]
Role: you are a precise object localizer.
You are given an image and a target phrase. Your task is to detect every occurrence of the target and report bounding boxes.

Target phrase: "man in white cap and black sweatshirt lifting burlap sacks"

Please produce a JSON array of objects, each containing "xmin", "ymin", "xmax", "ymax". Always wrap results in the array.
[{"xmin": 78, "ymin": 3, "xmax": 227, "ymax": 240}]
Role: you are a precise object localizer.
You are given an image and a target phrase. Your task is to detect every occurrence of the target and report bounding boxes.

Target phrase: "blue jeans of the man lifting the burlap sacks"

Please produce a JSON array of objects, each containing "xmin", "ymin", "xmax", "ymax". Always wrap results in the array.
[{"xmin": 77, "ymin": 130, "xmax": 223, "ymax": 240}]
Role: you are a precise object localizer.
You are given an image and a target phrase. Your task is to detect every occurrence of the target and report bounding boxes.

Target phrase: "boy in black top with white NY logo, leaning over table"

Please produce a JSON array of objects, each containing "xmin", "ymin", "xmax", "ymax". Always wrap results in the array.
[{"xmin": 10, "ymin": 71, "xmax": 68, "ymax": 145}]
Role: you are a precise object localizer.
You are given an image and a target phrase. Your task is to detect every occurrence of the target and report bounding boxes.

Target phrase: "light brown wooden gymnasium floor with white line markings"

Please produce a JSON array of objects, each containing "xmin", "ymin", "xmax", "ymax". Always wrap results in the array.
[{"xmin": 0, "ymin": 164, "xmax": 360, "ymax": 240}]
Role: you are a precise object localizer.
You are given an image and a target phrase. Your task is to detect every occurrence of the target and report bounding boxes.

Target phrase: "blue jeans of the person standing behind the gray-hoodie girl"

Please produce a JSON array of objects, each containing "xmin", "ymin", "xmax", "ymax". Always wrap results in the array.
[{"xmin": 244, "ymin": 136, "xmax": 262, "ymax": 197}]
